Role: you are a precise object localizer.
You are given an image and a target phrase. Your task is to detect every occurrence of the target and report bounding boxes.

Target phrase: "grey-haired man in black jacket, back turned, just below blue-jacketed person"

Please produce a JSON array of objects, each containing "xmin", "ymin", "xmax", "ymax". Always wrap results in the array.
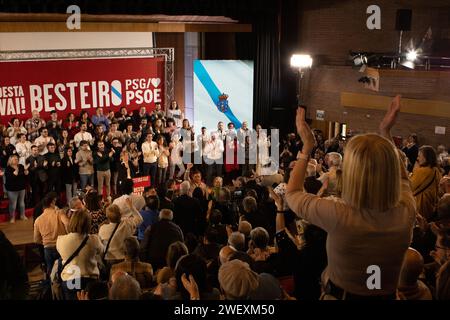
[{"xmin": 141, "ymin": 209, "xmax": 184, "ymax": 270}]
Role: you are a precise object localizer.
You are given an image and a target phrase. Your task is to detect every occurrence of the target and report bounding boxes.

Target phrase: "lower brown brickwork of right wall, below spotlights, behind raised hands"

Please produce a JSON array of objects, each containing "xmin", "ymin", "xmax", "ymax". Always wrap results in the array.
[{"xmin": 306, "ymin": 66, "xmax": 450, "ymax": 146}]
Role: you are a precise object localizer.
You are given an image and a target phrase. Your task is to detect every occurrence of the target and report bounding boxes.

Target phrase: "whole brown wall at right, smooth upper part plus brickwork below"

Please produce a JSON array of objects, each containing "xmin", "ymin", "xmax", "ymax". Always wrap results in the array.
[{"xmin": 298, "ymin": 0, "xmax": 450, "ymax": 146}]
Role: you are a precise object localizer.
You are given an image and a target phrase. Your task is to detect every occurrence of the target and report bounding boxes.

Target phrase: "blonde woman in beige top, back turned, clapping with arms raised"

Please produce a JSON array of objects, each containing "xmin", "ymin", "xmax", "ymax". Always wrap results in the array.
[{"xmin": 286, "ymin": 96, "xmax": 415, "ymax": 300}]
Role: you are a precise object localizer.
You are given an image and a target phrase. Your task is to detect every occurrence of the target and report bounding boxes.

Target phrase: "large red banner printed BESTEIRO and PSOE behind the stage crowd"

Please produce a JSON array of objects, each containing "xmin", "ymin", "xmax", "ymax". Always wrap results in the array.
[{"xmin": 0, "ymin": 57, "xmax": 165, "ymax": 124}]
